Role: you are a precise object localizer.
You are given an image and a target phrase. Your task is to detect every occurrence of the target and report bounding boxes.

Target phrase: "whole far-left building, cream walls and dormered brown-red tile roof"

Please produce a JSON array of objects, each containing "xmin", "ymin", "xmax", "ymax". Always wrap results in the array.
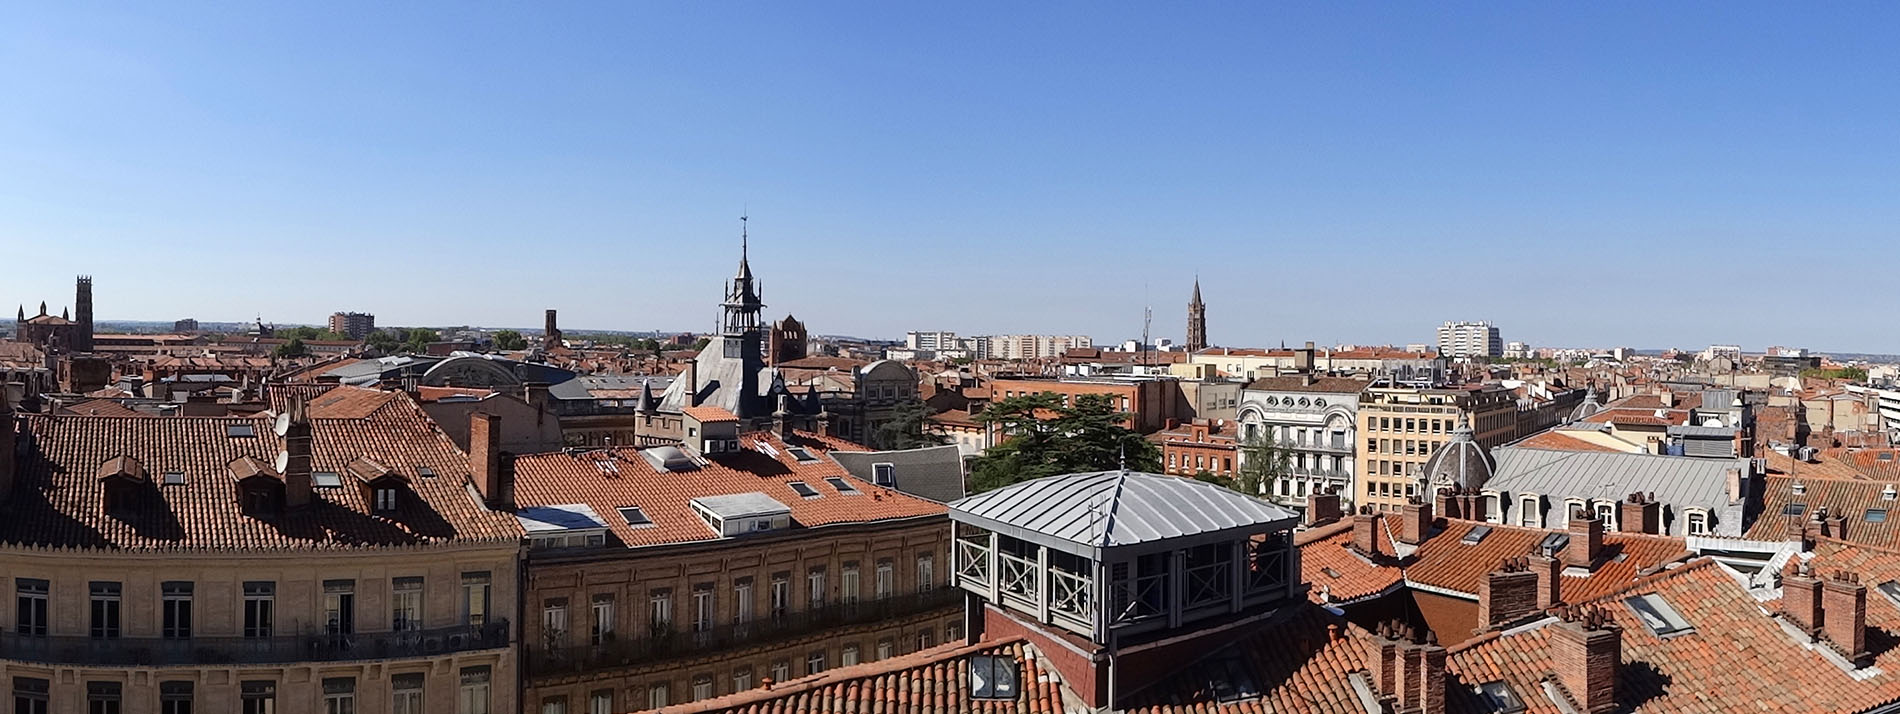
[{"xmin": 0, "ymin": 393, "xmax": 521, "ymax": 714}]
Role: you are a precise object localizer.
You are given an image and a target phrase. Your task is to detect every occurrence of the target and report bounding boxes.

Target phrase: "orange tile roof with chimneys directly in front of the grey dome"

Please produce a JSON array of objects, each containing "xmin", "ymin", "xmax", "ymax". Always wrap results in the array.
[{"xmin": 1406, "ymin": 518, "xmax": 1689, "ymax": 602}]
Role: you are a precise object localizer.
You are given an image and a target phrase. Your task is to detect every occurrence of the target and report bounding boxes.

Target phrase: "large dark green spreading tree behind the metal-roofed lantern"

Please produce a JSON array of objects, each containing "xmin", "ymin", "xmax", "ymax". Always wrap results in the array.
[{"xmin": 971, "ymin": 393, "xmax": 1161, "ymax": 492}]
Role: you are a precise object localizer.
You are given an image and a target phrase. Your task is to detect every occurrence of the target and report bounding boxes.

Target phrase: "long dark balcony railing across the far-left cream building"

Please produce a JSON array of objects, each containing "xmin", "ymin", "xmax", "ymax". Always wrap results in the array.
[{"xmin": 0, "ymin": 619, "xmax": 509, "ymax": 667}]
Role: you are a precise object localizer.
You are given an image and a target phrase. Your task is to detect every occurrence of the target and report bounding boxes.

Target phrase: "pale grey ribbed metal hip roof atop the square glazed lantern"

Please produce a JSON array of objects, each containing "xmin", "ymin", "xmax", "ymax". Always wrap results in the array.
[{"xmin": 950, "ymin": 471, "xmax": 1296, "ymax": 553}]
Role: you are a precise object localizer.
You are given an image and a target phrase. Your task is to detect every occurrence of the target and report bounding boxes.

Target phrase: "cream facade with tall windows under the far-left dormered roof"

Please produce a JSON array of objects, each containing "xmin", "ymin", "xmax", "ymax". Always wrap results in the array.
[{"xmin": 0, "ymin": 541, "xmax": 519, "ymax": 714}]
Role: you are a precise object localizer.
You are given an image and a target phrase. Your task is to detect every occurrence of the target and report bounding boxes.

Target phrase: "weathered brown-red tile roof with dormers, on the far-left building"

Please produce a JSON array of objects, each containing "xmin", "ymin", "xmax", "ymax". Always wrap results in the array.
[{"xmin": 0, "ymin": 393, "xmax": 521, "ymax": 549}]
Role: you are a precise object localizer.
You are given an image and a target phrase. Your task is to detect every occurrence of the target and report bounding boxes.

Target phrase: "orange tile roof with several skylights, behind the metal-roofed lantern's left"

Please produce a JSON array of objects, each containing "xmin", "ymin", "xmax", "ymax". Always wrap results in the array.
[{"xmin": 515, "ymin": 431, "xmax": 946, "ymax": 547}]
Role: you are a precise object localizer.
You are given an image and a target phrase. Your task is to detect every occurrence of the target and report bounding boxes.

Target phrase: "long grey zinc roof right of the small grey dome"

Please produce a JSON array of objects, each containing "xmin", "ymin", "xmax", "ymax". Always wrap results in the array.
[{"xmin": 1484, "ymin": 446, "xmax": 1742, "ymax": 520}]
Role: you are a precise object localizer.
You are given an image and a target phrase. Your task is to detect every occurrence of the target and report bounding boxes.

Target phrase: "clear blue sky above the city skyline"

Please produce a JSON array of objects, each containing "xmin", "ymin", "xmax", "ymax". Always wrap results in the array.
[{"xmin": 0, "ymin": 2, "xmax": 1900, "ymax": 353}]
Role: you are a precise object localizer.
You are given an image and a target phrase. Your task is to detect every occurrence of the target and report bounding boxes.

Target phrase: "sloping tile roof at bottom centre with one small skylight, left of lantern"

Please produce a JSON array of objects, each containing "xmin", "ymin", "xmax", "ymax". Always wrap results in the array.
[{"xmin": 638, "ymin": 640, "xmax": 1066, "ymax": 714}]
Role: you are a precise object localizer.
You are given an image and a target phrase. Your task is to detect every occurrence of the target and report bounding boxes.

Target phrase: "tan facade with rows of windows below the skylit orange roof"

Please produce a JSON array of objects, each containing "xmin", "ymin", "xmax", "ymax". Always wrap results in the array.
[{"xmin": 523, "ymin": 515, "xmax": 963, "ymax": 712}]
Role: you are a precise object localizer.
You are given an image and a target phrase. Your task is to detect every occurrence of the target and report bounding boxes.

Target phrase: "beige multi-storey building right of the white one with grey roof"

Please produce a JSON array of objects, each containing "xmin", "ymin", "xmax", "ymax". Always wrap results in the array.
[{"xmin": 1355, "ymin": 384, "xmax": 1518, "ymax": 511}]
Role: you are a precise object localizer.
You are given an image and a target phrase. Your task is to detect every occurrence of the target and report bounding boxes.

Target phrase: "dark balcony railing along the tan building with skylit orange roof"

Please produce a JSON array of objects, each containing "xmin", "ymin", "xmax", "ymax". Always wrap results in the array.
[{"xmin": 526, "ymin": 587, "xmax": 963, "ymax": 676}]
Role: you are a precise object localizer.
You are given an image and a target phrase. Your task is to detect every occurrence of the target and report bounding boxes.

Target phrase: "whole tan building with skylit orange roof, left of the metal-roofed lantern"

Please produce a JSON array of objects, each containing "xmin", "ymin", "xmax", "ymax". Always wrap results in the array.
[{"xmin": 517, "ymin": 408, "xmax": 961, "ymax": 712}]
